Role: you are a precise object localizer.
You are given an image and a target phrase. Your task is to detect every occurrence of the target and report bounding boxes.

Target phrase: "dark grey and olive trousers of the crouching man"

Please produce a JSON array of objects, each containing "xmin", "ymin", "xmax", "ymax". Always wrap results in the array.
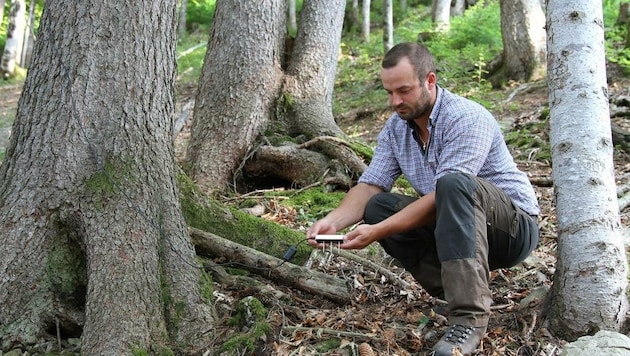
[{"xmin": 364, "ymin": 173, "xmax": 539, "ymax": 327}]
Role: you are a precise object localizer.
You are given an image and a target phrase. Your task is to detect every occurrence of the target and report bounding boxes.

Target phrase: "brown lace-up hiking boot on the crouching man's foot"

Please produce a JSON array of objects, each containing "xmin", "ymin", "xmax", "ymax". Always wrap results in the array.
[{"xmin": 431, "ymin": 324, "xmax": 486, "ymax": 356}]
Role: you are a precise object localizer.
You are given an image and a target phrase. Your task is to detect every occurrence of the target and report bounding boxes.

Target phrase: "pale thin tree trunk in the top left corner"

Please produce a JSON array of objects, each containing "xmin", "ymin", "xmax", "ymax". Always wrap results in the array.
[{"xmin": 0, "ymin": 0, "xmax": 26, "ymax": 79}]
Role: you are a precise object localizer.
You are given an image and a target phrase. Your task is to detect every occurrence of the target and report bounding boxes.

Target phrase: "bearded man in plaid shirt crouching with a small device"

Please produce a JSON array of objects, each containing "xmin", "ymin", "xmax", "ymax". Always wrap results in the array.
[{"xmin": 307, "ymin": 43, "xmax": 540, "ymax": 356}]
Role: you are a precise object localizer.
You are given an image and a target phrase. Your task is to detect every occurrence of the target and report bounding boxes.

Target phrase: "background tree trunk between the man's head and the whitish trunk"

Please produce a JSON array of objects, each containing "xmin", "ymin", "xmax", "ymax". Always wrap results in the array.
[{"xmin": 490, "ymin": 0, "xmax": 547, "ymax": 87}]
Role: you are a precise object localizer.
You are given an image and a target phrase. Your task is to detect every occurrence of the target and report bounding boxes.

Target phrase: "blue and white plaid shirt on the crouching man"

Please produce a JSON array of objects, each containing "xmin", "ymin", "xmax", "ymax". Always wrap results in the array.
[{"xmin": 359, "ymin": 87, "xmax": 540, "ymax": 215}]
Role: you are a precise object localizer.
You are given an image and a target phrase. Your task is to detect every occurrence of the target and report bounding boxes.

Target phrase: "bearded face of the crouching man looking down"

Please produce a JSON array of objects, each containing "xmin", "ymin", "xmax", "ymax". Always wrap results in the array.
[{"xmin": 381, "ymin": 57, "xmax": 432, "ymax": 121}]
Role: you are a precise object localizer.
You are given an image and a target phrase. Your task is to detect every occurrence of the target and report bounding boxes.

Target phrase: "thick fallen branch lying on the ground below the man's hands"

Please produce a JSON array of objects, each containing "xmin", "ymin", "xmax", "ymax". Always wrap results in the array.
[{"xmin": 188, "ymin": 227, "xmax": 351, "ymax": 304}]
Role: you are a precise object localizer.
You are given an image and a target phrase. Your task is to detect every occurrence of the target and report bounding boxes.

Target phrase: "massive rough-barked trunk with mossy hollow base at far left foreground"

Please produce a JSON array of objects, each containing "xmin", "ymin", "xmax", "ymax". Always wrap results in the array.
[{"xmin": 0, "ymin": 0, "xmax": 213, "ymax": 355}]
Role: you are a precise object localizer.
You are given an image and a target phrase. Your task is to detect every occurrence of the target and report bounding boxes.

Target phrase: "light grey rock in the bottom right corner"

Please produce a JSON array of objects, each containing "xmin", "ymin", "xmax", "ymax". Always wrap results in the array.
[{"xmin": 560, "ymin": 330, "xmax": 630, "ymax": 356}]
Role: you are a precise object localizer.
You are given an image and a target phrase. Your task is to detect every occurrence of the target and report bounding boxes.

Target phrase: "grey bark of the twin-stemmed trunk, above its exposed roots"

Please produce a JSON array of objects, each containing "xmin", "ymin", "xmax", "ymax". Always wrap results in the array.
[{"xmin": 187, "ymin": 0, "xmax": 345, "ymax": 190}]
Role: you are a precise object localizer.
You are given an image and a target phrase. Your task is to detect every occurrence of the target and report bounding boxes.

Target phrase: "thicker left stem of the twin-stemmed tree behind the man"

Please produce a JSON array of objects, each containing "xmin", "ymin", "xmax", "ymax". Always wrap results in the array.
[{"xmin": 187, "ymin": 0, "xmax": 286, "ymax": 190}]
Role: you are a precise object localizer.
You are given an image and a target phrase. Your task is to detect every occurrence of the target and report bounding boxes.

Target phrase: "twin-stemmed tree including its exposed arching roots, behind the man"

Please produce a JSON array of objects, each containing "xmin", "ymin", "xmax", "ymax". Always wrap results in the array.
[{"xmin": 187, "ymin": 0, "xmax": 364, "ymax": 191}]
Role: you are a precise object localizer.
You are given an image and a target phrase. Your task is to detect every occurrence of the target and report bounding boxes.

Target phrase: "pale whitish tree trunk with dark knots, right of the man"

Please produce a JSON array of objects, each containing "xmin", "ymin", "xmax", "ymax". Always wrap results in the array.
[{"xmin": 547, "ymin": 0, "xmax": 628, "ymax": 341}]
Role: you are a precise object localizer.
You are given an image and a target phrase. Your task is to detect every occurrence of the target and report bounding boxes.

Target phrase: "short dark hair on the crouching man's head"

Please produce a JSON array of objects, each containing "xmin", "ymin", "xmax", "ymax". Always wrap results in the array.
[{"xmin": 381, "ymin": 42, "xmax": 436, "ymax": 79}]
